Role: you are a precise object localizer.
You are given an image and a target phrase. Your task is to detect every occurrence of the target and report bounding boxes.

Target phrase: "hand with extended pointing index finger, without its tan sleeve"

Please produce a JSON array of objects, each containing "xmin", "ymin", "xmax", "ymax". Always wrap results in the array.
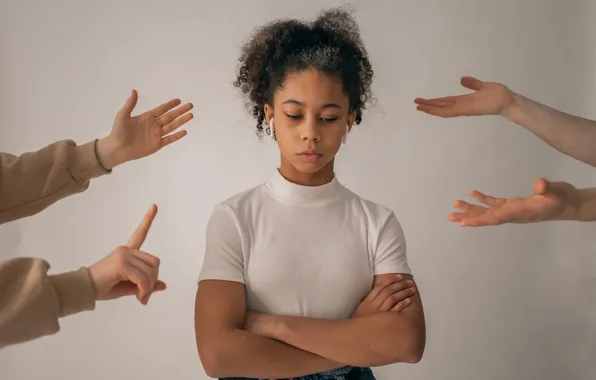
[{"xmin": 89, "ymin": 205, "xmax": 166, "ymax": 305}]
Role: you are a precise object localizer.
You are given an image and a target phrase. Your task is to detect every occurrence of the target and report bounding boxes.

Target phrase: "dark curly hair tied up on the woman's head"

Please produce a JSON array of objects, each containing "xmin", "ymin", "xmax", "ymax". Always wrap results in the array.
[{"xmin": 234, "ymin": 7, "xmax": 373, "ymax": 136}]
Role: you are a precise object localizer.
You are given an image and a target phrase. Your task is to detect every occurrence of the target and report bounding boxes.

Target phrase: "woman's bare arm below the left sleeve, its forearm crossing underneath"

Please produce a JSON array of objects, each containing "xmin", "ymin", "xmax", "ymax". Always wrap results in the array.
[{"xmin": 195, "ymin": 280, "xmax": 343, "ymax": 379}]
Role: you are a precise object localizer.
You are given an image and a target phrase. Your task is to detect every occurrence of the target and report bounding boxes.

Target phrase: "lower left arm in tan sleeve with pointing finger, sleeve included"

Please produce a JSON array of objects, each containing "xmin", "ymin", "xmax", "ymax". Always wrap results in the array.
[{"xmin": 0, "ymin": 206, "xmax": 165, "ymax": 349}]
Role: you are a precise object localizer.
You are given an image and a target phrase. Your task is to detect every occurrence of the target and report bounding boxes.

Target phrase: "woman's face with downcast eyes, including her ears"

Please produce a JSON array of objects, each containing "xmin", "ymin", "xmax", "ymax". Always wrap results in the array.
[{"xmin": 265, "ymin": 69, "xmax": 356, "ymax": 184}]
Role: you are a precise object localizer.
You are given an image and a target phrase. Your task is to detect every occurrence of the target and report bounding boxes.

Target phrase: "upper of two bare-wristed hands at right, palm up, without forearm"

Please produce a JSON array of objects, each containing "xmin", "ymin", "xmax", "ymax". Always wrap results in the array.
[{"xmin": 414, "ymin": 77, "xmax": 514, "ymax": 118}]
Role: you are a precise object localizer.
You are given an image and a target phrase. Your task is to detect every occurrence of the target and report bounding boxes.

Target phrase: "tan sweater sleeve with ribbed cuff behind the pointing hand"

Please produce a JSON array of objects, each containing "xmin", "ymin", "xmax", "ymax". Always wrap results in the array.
[{"xmin": 0, "ymin": 258, "xmax": 95, "ymax": 348}]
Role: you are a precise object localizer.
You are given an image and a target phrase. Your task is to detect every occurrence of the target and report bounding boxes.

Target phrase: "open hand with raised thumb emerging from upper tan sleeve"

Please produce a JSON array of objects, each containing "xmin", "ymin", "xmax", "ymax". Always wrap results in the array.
[{"xmin": 97, "ymin": 90, "xmax": 193, "ymax": 169}]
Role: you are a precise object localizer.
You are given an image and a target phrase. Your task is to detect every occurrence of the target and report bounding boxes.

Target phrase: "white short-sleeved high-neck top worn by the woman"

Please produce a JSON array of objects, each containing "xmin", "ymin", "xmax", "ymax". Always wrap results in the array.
[{"xmin": 199, "ymin": 170, "xmax": 411, "ymax": 320}]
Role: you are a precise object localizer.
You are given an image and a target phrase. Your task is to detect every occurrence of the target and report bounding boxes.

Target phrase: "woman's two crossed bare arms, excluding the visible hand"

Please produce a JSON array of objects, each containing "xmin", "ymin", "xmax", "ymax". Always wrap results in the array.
[{"xmin": 195, "ymin": 275, "xmax": 426, "ymax": 378}]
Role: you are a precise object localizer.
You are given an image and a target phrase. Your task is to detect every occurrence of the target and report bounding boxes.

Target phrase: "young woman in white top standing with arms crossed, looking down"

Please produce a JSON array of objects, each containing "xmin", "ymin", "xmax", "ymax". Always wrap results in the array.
[{"xmin": 195, "ymin": 9, "xmax": 426, "ymax": 379}]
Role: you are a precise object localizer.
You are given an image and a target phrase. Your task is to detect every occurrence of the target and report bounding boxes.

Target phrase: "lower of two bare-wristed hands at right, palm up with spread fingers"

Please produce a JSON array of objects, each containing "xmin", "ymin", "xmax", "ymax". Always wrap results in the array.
[{"xmin": 449, "ymin": 179, "xmax": 580, "ymax": 227}]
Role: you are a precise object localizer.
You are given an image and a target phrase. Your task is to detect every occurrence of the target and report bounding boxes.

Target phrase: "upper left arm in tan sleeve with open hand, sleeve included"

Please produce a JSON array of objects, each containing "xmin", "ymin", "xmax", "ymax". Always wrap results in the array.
[{"xmin": 0, "ymin": 91, "xmax": 193, "ymax": 224}]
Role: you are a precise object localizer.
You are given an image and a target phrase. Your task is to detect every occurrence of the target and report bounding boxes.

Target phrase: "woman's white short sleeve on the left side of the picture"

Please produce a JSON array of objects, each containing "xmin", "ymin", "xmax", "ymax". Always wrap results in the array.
[{"xmin": 199, "ymin": 205, "xmax": 245, "ymax": 284}]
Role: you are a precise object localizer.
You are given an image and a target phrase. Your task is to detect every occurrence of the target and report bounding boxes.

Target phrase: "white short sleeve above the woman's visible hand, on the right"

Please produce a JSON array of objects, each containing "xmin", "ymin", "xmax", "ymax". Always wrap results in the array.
[{"xmin": 373, "ymin": 212, "xmax": 412, "ymax": 276}]
